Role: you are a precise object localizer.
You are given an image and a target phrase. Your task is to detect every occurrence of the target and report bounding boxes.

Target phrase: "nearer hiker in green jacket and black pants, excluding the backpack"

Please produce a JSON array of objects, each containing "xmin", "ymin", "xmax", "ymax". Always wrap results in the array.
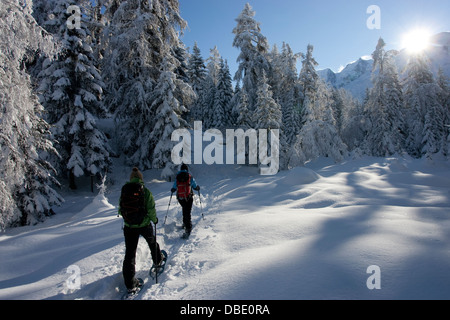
[{"xmin": 119, "ymin": 168, "xmax": 163, "ymax": 291}]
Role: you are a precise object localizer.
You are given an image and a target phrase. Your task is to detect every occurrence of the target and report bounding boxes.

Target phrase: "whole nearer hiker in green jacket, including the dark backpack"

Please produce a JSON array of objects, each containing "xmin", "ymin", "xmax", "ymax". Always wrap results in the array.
[{"xmin": 119, "ymin": 168, "xmax": 163, "ymax": 291}]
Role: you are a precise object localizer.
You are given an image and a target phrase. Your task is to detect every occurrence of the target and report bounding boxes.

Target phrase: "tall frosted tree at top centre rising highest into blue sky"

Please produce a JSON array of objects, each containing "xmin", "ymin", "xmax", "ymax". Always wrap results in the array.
[{"xmin": 233, "ymin": 3, "xmax": 270, "ymax": 116}]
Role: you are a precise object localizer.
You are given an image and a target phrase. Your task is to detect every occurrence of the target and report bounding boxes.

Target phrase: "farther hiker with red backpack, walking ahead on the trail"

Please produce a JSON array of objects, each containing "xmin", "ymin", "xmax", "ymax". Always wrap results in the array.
[{"xmin": 171, "ymin": 164, "xmax": 200, "ymax": 233}]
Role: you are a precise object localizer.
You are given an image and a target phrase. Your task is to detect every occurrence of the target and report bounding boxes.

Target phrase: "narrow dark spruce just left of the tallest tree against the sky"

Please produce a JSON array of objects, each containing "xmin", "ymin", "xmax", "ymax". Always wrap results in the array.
[{"xmin": 213, "ymin": 59, "xmax": 234, "ymax": 128}]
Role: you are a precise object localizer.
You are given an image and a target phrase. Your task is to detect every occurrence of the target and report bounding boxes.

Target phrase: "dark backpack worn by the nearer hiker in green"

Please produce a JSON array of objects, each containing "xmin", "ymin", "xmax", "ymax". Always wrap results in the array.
[{"xmin": 120, "ymin": 183, "xmax": 147, "ymax": 225}]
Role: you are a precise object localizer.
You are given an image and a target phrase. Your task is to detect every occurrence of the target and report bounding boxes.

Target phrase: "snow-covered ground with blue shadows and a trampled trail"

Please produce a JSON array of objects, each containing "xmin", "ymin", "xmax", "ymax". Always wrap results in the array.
[{"xmin": 0, "ymin": 158, "xmax": 450, "ymax": 300}]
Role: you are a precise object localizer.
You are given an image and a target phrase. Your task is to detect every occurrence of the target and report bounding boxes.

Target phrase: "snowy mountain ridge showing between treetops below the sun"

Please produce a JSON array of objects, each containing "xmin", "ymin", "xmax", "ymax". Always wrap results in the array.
[{"xmin": 317, "ymin": 32, "xmax": 450, "ymax": 101}]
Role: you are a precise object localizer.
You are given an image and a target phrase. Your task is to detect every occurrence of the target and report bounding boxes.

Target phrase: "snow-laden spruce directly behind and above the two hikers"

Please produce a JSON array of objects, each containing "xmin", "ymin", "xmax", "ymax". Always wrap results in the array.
[{"xmin": 150, "ymin": 57, "xmax": 195, "ymax": 179}]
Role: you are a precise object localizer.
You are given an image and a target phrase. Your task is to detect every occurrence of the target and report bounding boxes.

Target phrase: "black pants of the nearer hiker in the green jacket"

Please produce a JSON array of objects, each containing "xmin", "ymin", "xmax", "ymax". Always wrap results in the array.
[{"xmin": 122, "ymin": 224, "xmax": 161, "ymax": 289}]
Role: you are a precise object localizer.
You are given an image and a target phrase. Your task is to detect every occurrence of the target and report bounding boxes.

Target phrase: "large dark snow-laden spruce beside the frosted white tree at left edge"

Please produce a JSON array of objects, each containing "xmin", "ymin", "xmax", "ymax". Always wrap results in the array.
[{"xmin": 39, "ymin": 0, "xmax": 111, "ymax": 189}]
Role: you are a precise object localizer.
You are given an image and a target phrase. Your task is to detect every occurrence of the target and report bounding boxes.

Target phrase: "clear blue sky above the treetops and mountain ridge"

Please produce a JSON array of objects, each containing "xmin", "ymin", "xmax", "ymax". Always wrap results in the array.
[{"xmin": 179, "ymin": 0, "xmax": 450, "ymax": 76}]
